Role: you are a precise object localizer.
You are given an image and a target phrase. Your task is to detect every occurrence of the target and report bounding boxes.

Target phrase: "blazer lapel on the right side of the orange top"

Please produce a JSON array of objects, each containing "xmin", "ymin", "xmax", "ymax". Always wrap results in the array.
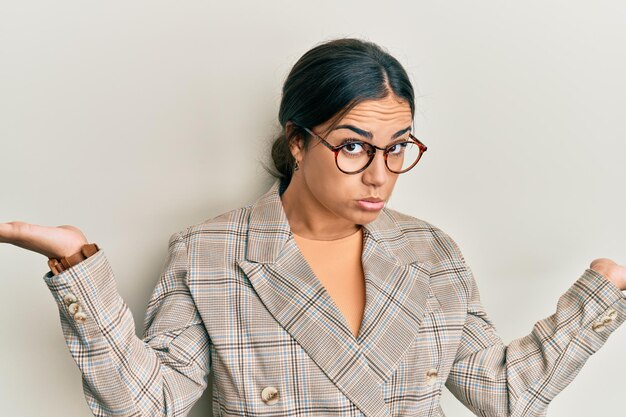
[{"xmin": 357, "ymin": 211, "xmax": 431, "ymax": 381}]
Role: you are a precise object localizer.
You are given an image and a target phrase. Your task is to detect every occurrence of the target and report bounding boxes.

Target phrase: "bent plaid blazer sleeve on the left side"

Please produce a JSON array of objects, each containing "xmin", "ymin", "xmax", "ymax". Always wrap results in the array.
[{"xmin": 44, "ymin": 232, "xmax": 211, "ymax": 417}]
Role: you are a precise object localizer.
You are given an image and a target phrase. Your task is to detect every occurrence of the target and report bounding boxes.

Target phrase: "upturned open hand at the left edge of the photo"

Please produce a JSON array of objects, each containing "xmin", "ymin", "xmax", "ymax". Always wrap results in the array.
[{"xmin": 0, "ymin": 221, "xmax": 88, "ymax": 258}]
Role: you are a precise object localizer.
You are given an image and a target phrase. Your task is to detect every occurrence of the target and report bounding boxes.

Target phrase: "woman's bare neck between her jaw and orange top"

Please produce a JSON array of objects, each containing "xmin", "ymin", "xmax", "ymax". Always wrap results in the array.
[{"xmin": 281, "ymin": 176, "xmax": 361, "ymax": 240}]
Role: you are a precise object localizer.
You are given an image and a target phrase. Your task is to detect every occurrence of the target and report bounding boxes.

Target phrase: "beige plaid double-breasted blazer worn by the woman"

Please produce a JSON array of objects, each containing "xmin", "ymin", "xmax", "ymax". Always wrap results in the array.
[{"xmin": 44, "ymin": 182, "xmax": 626, "ymax": 417}]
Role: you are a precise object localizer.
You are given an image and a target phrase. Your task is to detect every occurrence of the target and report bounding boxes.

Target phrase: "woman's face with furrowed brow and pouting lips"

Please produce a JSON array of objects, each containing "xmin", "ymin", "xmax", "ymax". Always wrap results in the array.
[{"xmin": 292, "ymin": 95, "xmax": 413, "ymax": 225}]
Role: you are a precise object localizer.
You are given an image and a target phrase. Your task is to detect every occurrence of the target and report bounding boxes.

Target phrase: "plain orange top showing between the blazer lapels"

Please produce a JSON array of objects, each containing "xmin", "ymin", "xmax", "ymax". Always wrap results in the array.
[{"xmin": 293, "ymin": 228, "xmax": 365, "ymax": 337}]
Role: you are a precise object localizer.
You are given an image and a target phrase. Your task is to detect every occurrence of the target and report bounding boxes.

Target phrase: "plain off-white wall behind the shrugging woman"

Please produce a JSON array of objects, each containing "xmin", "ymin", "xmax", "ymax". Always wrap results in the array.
[{"xmin": 0, "ymin": 0, "xmax": 626, "ymax": 417}]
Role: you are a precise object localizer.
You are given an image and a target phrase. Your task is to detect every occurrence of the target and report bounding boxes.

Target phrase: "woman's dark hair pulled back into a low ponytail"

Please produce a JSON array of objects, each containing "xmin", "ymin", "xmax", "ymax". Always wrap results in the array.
[{"xmin": 268, "ymin": 38, "xmax": 415, "ymax": 189}]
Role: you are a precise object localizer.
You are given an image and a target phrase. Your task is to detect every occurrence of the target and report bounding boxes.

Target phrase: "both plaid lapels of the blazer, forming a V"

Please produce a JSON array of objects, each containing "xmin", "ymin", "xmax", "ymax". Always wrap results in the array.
[{"xmin": 238, "ymin": 182, "xmax": 430, "ymax": 417}]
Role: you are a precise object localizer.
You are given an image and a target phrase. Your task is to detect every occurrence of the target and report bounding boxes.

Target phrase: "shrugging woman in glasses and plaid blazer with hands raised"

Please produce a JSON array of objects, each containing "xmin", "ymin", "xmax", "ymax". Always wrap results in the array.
[{"xmin": 0, "ymin": 39, "xmax": 626, "ymax": 416}]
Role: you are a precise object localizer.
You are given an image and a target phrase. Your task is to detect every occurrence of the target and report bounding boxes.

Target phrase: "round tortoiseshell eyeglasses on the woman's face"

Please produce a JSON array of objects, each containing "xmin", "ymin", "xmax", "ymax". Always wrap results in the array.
[{"xmin": 302, "ymin": 127, "xmax": 428, "ymax": 174}]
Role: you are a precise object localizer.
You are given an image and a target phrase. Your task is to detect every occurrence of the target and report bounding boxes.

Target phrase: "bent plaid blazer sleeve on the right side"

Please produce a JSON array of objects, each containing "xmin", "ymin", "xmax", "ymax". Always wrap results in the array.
[{"xmin": 446, "ymin": 237, "xmax": 626, "ymax": 417}]
